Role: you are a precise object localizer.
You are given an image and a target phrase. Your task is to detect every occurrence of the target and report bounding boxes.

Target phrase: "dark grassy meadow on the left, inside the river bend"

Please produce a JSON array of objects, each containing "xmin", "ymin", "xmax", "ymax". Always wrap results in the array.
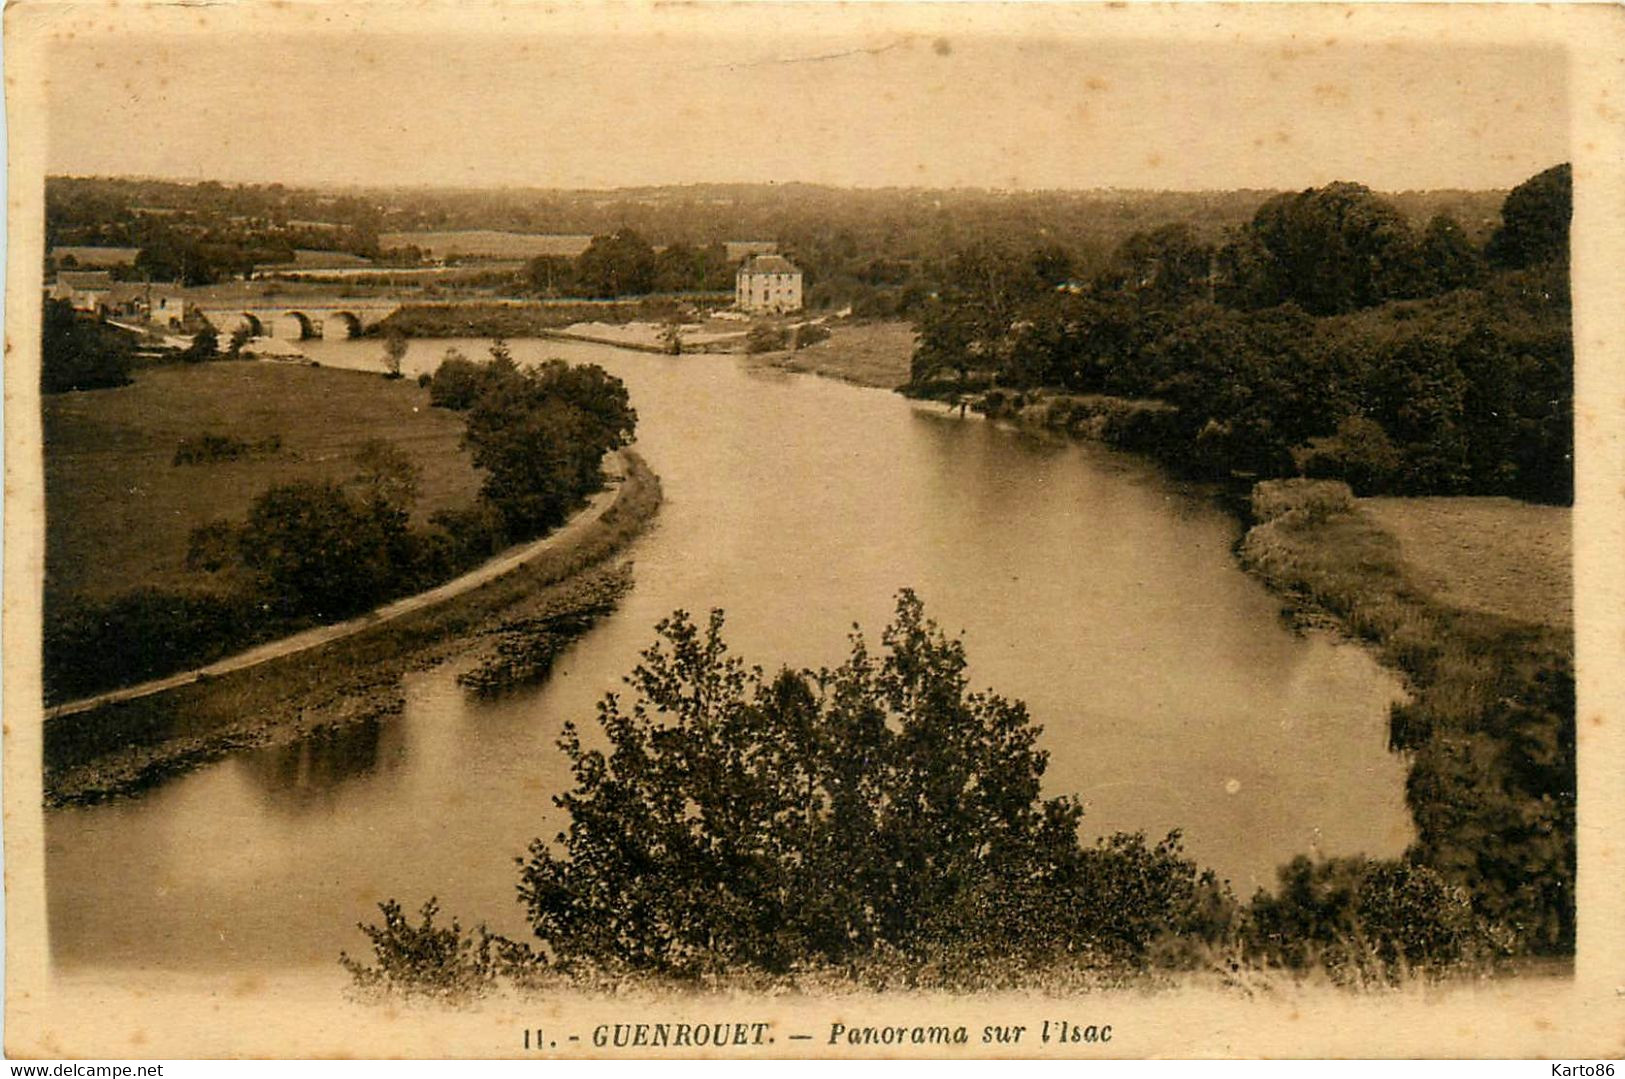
[{"xmin": 44, "ymin": 362, "xmax": 481, "ymax": 600}]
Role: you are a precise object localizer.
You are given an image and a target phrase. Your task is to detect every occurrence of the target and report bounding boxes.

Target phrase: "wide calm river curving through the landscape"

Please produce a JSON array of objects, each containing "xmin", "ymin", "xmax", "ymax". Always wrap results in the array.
[{"xmin": 46, "ymin": 341, "xmax": 1412, "ymax": 972}]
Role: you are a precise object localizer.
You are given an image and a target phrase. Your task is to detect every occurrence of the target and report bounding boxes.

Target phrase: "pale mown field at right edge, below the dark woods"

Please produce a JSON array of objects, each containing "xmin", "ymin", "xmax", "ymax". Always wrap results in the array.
[{"xmin": 1360, "ymin": 499, "xmax": 1575, "ymax": 629}]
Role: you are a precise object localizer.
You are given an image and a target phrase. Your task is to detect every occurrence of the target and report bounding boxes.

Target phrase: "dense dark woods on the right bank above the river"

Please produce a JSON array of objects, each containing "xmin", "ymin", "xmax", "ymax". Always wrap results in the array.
[{"xmin": 910, "ymin": 164, "xmax": 1573, "ymax": 504}]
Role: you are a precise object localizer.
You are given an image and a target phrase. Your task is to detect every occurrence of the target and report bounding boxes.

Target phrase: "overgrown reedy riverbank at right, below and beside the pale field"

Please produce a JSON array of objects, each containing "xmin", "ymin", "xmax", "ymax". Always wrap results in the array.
[{"xmin": 1240, "ymin": 481, "xmax": 1576, "ymax": 956}]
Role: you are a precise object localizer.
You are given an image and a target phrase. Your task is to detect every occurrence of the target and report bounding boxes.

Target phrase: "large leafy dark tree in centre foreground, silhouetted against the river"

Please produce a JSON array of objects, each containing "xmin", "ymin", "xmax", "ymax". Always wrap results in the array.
[{"xmin": 520, "ymin": 590, "xmax": 1219, "ymax": 975}]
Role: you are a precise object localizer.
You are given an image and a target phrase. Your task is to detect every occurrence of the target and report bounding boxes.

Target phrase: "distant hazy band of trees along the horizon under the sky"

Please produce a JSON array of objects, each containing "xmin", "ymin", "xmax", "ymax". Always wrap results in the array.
[{"xmin": 46, "ymin": 177, "xmax": 1505, "ymax": 303}]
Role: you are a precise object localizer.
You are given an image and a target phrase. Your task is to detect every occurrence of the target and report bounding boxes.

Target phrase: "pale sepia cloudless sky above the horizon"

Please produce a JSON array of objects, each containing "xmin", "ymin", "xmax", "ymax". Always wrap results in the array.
[{"xmin": 46, "ymin": 10, "xmax": 1568, "ymax": 190}]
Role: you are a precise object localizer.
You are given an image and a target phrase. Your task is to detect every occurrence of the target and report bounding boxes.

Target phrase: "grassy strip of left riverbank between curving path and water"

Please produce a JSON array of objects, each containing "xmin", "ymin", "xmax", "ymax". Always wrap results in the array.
[{"xmin": 44, "ymin": 453, "xmax": 661, "ymax": 806}]
